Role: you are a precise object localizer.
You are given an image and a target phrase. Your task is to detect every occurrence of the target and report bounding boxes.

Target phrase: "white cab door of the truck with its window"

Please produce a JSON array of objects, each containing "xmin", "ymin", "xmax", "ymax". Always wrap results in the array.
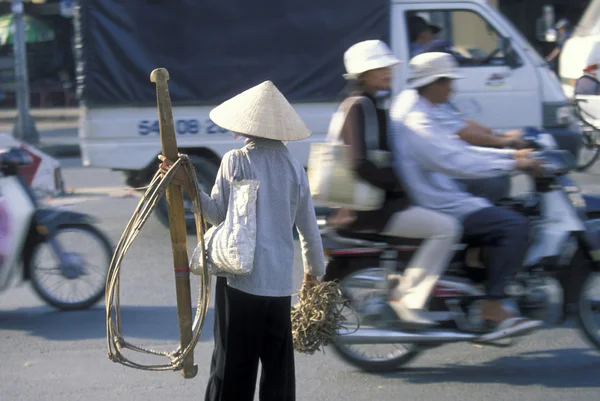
[{"xmin": 391, "ymin": 1, "xmax": 542, "ymax": 129}]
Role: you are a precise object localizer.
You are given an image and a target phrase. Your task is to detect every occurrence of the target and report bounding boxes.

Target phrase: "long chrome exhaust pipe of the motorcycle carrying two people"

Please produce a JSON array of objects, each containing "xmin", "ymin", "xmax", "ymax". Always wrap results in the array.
[{"xmin": 335, "ymin": 329, "xmax": 477, "ymax": 344}]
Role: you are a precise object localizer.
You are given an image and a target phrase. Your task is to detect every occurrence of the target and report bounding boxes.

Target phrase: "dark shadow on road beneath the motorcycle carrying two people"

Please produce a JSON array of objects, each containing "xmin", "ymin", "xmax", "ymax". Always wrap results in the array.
[{"xmin": 381, "ymin": 348, "xmax": 600, "ymax": 388}]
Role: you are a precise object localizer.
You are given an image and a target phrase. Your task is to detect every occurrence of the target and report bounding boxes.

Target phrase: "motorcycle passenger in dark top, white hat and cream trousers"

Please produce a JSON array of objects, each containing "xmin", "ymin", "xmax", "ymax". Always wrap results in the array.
[{"xmin": 328, "ymin": 40, "xmax": 461, "ymax": 325}]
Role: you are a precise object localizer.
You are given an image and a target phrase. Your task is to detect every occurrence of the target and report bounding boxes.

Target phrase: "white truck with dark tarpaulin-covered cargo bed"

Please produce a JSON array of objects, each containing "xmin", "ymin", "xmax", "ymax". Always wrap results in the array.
[{"xmin": 76, "ymin": 0, "xmax": 580, "ymax": 228}]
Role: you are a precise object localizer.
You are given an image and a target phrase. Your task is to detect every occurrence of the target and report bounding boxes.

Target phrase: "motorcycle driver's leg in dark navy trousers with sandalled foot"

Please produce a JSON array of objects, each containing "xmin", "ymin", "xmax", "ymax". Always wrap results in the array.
[{"xmin": 463, "ymin": 207, "xmax": 539, "ymax": 331}]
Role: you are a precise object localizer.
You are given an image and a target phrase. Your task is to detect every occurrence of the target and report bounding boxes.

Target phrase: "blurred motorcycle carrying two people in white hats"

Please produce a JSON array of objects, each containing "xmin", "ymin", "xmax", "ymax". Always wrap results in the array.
[{"xmin": 319, "ymin": 133, "xmax": 600, "ymax": 371}]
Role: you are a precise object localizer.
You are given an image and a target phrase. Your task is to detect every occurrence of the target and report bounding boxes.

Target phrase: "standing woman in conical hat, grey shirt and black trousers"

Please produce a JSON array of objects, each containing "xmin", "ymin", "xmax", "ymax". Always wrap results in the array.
[{"xmin": 160, "ymin": 81, "xmax": 325, "ymax": 401}]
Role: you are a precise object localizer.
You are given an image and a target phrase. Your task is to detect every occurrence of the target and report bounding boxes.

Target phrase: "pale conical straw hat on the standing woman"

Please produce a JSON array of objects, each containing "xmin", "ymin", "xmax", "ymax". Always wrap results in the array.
[{"xmin": 210, "ymin": 81, "xmax": 311, "ymax": 141}]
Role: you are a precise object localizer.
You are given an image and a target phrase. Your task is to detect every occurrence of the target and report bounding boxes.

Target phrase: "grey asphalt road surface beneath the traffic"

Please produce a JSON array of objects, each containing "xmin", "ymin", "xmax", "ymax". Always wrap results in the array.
[{"xmin": 0, "ymin": 159, "xmax": 600, "ymax": 401}]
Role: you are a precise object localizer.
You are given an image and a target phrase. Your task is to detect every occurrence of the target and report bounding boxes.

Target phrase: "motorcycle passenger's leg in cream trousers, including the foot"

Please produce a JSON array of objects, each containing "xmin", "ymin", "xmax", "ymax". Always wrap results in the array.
[{"xmin": 382, "ymin": 207, "xmax": 462, "ymax": 324}]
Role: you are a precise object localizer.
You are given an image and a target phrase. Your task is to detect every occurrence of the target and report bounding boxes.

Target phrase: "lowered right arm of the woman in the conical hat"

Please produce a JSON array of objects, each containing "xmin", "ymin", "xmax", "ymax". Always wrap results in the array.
[{"xmin": 294, "ymin": 169, "xmax": 325, "ymax": 277}]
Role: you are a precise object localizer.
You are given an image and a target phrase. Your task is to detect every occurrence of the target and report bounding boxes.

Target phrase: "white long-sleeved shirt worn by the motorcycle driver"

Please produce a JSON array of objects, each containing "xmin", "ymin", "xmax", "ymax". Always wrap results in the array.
[{"xmin": 390, "ymin": 90, "xmax": 516, "ymax": 220}]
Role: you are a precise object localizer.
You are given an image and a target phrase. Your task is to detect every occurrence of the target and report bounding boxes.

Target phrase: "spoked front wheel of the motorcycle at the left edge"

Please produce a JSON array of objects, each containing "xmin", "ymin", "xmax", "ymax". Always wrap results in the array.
[{"xmin": 27, "ymin": 224, "xmax": 113, "ymax": 311}]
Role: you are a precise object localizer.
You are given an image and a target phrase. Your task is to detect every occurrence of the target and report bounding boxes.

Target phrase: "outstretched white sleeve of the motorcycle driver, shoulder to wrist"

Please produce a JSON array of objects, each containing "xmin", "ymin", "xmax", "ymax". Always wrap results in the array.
[{"xmin": 393, "ymin": 111, "xmax": 517, "ymax": 178}]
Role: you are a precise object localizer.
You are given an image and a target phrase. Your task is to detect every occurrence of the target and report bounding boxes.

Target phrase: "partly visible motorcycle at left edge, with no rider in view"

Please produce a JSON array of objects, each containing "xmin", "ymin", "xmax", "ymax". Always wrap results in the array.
[{"xmin": 0, "ymin": 148, "xmax": 113, "ymax": 310}]
